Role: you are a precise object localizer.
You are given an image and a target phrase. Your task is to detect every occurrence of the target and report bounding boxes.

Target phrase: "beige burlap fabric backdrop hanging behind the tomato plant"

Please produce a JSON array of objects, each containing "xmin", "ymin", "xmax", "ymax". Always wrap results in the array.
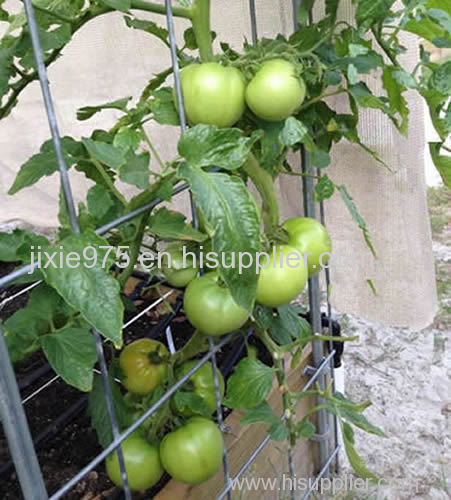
[{"xmin": 0, "ymin": 0, "xmax": 436, "ymax": 329}]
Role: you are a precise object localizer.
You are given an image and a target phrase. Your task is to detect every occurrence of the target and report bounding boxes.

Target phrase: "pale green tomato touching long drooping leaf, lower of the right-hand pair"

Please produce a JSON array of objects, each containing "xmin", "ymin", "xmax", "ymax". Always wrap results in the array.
[{"xmin": 256, "ymin": 245, "xmax": 308, "ymax": 307}]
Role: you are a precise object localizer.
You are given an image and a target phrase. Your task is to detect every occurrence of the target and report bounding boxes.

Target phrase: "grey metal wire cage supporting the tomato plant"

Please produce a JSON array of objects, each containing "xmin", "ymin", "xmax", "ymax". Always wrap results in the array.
[{"xmin": 0, "ymin": 0, "xmax": 339, "ymax": 500}]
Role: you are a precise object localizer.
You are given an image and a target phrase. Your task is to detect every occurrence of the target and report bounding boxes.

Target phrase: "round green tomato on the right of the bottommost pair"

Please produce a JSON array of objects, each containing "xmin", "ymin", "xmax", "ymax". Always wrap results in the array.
[{"xmin": 160, "ymin": 417, "xmax": 224, "ymax": 484}]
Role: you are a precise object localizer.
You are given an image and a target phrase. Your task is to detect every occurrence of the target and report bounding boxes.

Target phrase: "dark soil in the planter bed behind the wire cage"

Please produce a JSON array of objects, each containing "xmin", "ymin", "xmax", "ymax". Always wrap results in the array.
[{"xmin": 0, "ymin": 263, "xmax": 264, "ymax": 500}]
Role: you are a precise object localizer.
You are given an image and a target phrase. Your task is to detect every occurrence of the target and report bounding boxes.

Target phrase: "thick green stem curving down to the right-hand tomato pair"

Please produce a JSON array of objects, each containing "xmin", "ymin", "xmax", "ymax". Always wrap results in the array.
[{"xmin": 243, "ymin": 153, "xmax": 279, "ymax": 232}]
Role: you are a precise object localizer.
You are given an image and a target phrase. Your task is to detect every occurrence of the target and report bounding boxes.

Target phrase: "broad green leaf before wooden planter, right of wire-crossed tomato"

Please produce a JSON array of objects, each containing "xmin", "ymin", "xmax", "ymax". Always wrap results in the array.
[{"xmin": 224, "ymin": 358, "xmax": 274, "ymax": 409}]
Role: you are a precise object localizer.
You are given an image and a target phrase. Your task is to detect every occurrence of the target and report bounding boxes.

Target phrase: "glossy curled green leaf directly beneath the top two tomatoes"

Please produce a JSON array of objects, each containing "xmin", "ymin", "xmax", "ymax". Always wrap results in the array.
[{"xmin": 178, "ymin": 125, "xmax": 255, "ymax": 170}]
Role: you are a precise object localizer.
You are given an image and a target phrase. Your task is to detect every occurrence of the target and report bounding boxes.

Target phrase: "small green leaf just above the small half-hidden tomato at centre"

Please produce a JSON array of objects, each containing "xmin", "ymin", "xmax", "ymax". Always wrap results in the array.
[{"xmin": 148, "ymin": 208, "xmax": 208, "ymax": 243}]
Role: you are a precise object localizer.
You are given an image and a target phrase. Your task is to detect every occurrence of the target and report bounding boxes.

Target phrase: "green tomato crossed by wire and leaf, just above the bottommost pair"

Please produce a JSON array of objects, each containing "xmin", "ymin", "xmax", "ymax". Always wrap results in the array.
[{"xmin": 175, "ymin": 360, "xmax": 224, "ymax": 417}]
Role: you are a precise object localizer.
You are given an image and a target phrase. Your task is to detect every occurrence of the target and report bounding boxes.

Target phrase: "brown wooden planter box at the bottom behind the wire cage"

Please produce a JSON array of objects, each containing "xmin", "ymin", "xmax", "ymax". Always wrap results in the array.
[{"xmin": 155, "ymin": 349, "xmax": 318, "ymax": 500}]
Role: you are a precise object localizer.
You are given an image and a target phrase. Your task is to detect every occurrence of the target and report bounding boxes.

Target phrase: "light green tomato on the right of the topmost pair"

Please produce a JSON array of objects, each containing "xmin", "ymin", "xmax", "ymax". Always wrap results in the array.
[{"xmin": 246, "ymin": 59, "xmax": 306, "ymax": 121}]
